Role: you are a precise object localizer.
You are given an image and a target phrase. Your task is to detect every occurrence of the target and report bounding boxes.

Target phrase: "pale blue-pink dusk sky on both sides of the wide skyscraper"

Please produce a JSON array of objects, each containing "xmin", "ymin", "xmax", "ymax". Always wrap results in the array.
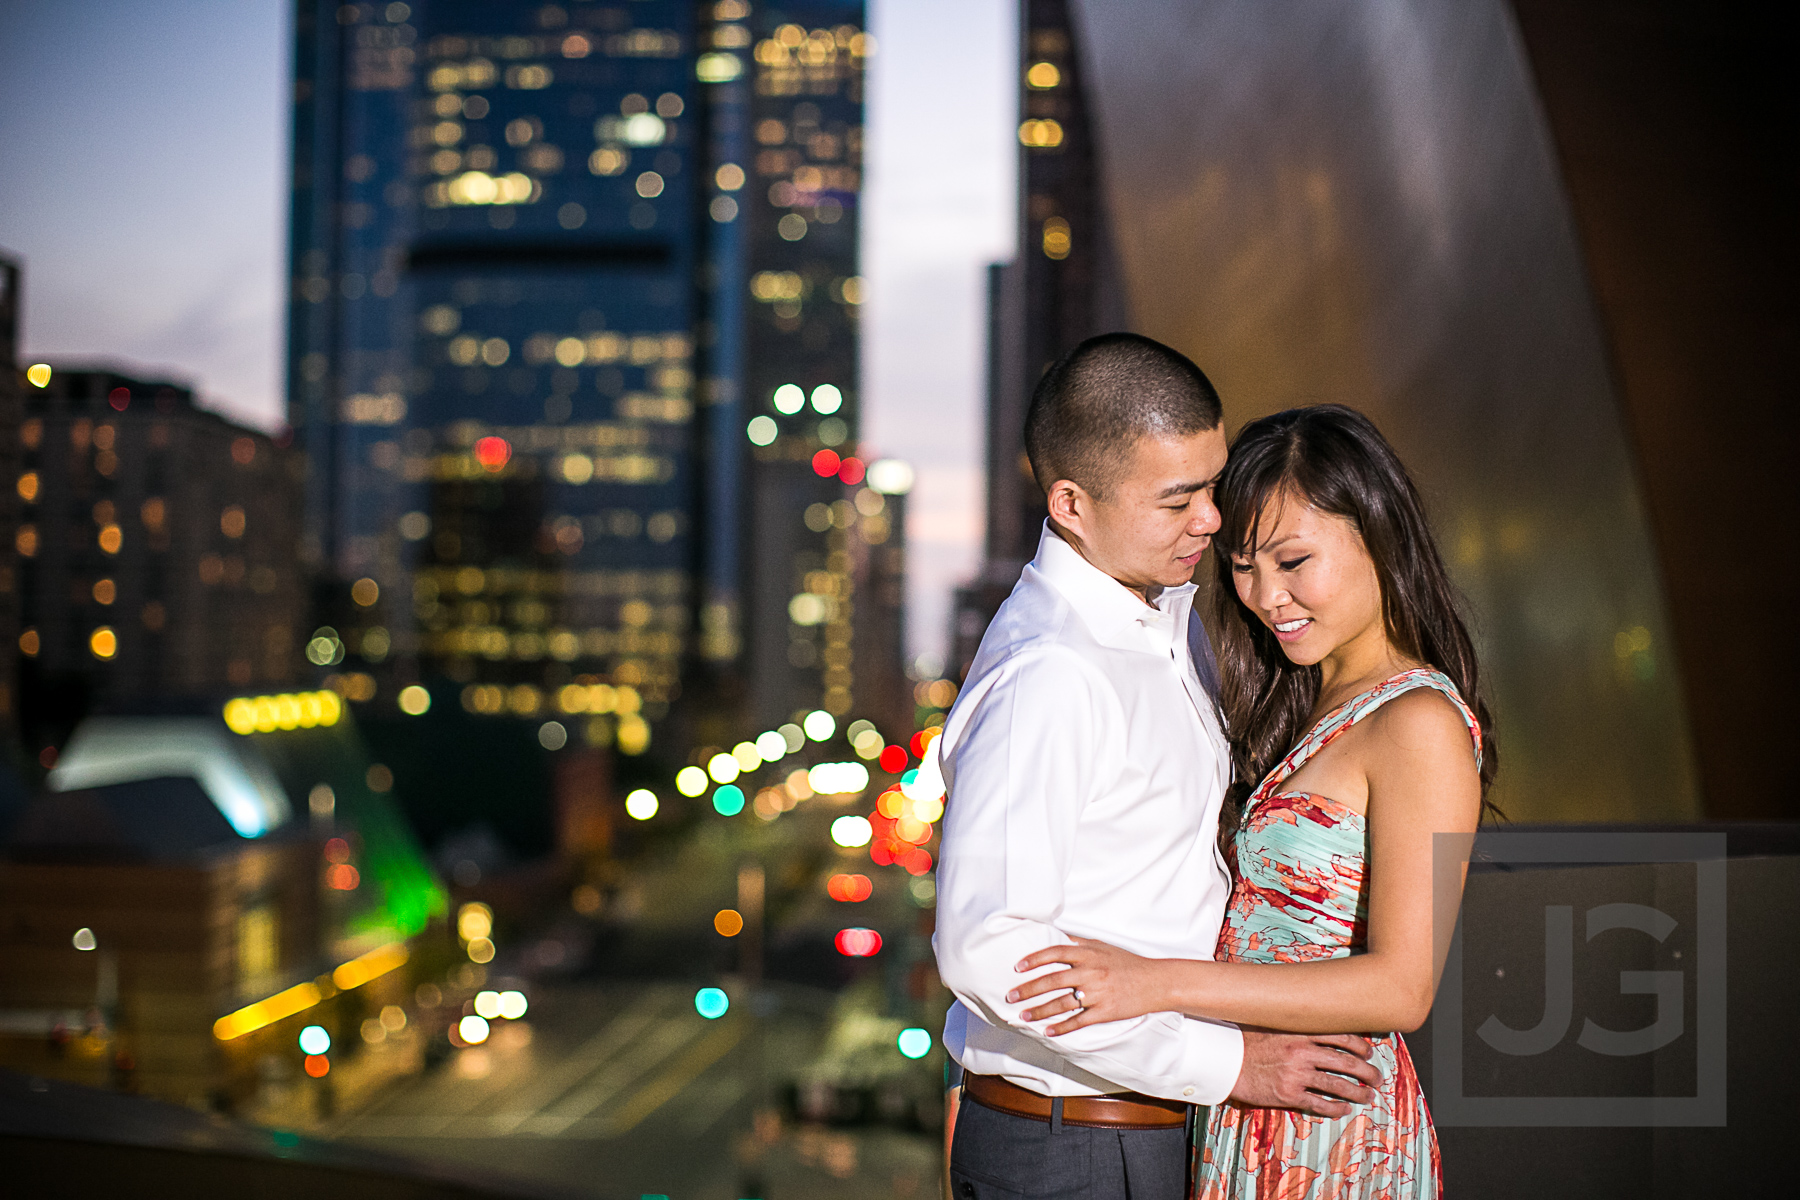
[{"xmin": 0, "ymin": 0, "xmax": 1013, "ymax": 653}]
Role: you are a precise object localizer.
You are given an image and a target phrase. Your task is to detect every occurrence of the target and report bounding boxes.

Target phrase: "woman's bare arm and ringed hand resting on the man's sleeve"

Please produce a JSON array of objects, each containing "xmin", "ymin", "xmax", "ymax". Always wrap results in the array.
[{"xmin": 1013, "ymin": 691, "xmax": 1481, "ymax": 1034}]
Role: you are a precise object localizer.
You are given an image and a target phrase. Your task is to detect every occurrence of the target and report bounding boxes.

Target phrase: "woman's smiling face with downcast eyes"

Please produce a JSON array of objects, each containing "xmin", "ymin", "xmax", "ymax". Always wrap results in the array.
[{"xmin": 1231, "ymin": 493, "xmax": 1386, "ymax": 666}]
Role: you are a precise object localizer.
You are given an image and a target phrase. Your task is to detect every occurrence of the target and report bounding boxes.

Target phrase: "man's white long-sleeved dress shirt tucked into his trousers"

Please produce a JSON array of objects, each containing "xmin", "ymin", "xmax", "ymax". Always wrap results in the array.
[{"xmin": 932, "ymin": 524, "xmax": 1244, "ymax": 1105}]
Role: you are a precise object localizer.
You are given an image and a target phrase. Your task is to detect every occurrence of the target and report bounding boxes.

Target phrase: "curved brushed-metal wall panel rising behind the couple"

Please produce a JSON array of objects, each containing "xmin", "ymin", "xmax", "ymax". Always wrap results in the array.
[{"xmin": 1076, "ymin": 0, "xmax": 1699, "ymax": 820}]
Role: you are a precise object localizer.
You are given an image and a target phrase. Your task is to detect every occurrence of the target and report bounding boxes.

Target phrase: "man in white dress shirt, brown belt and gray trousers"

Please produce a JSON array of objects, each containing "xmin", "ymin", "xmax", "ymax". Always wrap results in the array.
[{"xmin": 934, "ymin": 333, "xmax": 1377, "ymax": 1200}]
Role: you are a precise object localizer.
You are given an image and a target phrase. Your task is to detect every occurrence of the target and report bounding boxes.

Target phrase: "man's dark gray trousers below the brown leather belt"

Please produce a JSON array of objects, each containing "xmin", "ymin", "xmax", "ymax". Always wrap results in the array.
[{"xmin": 950, "ymin": 1094, "xmax": 1188, "ymax": 1200}]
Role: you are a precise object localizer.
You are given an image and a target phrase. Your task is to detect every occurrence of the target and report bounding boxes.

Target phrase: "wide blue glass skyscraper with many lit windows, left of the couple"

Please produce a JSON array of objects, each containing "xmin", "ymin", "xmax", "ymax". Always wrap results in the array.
[{"xmin": 290, "ymin": 0, "xmax": 892, "ymax": 766}]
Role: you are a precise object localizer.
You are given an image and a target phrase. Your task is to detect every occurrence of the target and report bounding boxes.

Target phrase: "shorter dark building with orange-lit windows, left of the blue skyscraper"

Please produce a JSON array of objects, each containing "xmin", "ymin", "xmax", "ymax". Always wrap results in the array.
[{"xmin": 13, "ymin": 367, "xmax": 306, "ymax": 752}]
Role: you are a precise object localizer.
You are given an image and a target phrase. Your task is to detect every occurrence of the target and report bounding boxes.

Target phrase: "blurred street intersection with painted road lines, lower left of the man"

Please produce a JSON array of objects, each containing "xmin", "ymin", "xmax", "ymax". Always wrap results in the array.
[{"xmin": 329, "ymin": 984, "xmax": 940, "ymax": 1200}]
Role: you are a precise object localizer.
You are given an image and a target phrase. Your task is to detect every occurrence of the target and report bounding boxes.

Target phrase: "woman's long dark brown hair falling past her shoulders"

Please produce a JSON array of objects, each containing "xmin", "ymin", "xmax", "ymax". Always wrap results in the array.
[{"xmin": 1213, "ymin": 405, "xmax": 1501, "ymax": 847}]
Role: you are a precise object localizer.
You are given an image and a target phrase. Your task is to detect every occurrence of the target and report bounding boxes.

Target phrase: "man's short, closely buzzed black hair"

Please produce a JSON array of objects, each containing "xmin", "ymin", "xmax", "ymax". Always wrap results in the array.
[{"xmin": 1024, "ymin": 333, "xmax": 1222, "ymax": 500}]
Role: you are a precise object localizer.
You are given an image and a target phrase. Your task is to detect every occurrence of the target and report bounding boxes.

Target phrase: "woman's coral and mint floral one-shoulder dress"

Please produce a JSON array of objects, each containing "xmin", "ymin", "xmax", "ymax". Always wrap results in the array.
[{"xmin": 1193, "ymin": 667, "xmax": 1481, "ymax": 1200}]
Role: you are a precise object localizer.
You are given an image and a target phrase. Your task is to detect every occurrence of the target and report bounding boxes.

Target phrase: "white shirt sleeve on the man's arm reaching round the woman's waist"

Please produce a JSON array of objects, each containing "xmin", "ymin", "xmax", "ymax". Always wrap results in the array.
[{"xmin": 934, "ymin": 646, "xmax": 1242, "ymax": 1105}]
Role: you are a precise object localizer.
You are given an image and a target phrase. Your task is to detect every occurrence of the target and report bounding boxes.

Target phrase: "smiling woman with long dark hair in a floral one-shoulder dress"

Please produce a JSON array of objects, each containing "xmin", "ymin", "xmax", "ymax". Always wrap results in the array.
[{"xmin": 1013, "ymin": 405, "xmax": 1494, "ymax": 1200}]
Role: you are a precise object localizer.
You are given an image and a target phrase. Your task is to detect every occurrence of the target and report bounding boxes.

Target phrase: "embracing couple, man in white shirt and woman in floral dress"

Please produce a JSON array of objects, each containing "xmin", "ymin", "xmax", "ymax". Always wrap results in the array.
[{"xmin": 936, "ymin": 335, "xmax": 1494, "ymax": 1200}]
